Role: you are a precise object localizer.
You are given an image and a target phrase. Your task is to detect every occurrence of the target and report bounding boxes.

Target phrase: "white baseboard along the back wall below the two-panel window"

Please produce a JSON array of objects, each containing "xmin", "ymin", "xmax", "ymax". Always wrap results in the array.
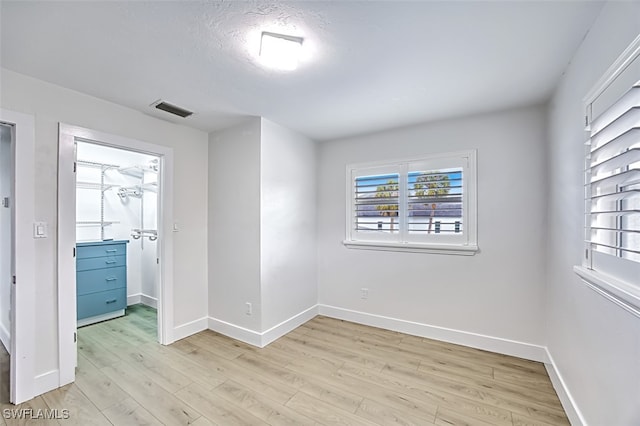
[{"xmin": 318, "ymin": 305, "xmax": 546, "ymax": 362}]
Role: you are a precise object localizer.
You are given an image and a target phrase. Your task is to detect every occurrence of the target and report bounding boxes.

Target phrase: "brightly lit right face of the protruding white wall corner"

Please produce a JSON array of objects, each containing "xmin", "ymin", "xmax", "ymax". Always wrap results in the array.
[{"xmin": 260, "ymin": 119, "xmax": 318, "ymax": 331}]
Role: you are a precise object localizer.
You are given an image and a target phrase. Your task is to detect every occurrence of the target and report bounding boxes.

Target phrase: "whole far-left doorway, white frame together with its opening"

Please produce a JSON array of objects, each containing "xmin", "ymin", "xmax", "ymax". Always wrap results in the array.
[{"xmin": 0, "ymin": 109, "xmax": 36, "ymax": 404}]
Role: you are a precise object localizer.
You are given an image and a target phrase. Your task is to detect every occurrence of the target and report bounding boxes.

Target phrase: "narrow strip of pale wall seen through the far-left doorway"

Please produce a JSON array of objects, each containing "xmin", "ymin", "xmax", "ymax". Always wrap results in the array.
[{"xmin": 0, "ymin": 126, "xmax": 13, "ymax": 351}]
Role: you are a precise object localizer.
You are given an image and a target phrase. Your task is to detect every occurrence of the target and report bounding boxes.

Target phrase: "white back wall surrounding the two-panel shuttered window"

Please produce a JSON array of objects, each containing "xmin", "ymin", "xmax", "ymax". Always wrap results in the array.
[{"xmin": 318, "ymin": 107, "xmax": 547, "ymax": 358}]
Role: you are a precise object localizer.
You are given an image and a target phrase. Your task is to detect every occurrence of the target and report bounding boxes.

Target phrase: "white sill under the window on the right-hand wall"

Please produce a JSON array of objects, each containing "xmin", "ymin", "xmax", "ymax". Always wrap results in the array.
[{"xmin": 573, "ymin": 266, "xmax": 640, "ymax": 318}]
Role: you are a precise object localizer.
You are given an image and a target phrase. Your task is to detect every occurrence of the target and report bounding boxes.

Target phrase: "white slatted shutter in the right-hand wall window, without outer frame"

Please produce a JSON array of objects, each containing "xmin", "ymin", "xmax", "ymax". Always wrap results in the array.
[{"xmin": 586, "ymin": 81, "xmax": 640, "ymax": 281}]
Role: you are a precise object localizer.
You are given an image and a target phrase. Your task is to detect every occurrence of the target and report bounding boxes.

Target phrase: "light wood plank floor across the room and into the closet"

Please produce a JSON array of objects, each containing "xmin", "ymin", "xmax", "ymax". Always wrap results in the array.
[{"xmin": 0, "ymin": 305, "xmax": 569, "ymax": 426}]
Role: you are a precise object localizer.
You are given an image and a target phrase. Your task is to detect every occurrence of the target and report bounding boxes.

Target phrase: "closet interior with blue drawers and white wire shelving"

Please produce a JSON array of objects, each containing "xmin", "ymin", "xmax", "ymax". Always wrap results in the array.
[{"xmin": 76, "ymin": 142, "xmax": 160, "ymax": 326}]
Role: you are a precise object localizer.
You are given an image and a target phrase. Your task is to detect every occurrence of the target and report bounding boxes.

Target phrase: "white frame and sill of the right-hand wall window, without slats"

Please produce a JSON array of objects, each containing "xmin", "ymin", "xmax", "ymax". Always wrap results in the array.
[{"xmin": 573, "ymin": 35, "xmax": 640, "ymax": 317}]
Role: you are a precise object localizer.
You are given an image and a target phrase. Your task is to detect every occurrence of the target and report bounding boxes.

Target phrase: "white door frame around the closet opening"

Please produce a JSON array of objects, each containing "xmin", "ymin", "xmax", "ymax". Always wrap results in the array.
[{"xmin": 58, "ymin": 123, "xmax": 174, "ymax": 386}]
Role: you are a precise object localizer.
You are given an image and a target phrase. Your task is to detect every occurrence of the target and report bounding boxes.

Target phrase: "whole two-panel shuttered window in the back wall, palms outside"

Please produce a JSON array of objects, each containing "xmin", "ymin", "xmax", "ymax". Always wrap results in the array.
[{"xmin": 344, "ymin": 151, "xmax": 477, "ymax": 254}]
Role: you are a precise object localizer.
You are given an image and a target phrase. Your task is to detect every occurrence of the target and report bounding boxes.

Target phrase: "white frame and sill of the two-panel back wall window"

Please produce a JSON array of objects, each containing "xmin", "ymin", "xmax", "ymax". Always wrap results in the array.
[{"xmin": 343, "ymin": 150, "xmax": 478, "ymax": 256}]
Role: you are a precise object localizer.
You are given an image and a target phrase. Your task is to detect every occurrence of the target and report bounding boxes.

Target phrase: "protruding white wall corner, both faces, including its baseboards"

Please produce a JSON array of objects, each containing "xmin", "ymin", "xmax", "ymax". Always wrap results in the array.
[{"xmin": 209, "ymin": 118, "xmax": 317, "ymax": 346}]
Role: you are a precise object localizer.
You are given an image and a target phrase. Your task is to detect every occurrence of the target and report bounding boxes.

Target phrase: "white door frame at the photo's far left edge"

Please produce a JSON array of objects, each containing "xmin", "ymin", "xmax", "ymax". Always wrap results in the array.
[{"xmin": 0, "ymin": 108, "xmax": 36, "ymax": 404}]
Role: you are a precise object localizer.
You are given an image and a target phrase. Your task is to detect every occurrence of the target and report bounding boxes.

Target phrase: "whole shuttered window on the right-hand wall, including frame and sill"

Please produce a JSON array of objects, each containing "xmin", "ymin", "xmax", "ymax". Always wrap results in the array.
[{"xmin": 574, "ymin": 36, "xmax": 640, "ymax": 316}]
